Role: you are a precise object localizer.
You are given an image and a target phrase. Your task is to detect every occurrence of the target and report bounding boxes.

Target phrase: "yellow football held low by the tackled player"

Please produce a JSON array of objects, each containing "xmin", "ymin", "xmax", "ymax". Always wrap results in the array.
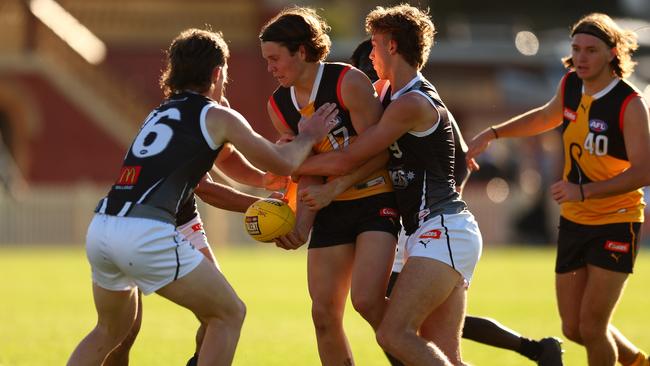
[{"xmin": 244, "ymin": 198, "xmax": 296, "ymax": 242}]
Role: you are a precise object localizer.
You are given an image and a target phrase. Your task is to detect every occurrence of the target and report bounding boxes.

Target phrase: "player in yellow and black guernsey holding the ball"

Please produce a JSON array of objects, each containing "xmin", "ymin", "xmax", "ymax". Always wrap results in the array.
[{"xmin": 260, "ymin": 7, "xmax": 399, "ymax": 365}]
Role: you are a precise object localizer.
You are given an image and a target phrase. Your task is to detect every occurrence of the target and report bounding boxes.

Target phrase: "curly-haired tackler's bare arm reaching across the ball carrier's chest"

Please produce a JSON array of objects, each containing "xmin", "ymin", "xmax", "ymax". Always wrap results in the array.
[{"xmin": 299, "ymin": 93, "xmax": 438, "ymax": 175}]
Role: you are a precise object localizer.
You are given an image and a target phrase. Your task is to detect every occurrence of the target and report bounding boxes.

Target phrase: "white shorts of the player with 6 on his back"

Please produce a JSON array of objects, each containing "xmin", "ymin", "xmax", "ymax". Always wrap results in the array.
[{"xmin": 86, "ymin": 214, "xmax": 204, "ymax": 295}]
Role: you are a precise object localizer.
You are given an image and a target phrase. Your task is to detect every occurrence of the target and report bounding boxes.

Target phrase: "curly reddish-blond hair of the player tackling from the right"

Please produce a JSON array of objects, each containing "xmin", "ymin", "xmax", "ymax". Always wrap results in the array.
[{"xmin": 366, "ymin": 4, "xmax": 436, "ymax": 70}]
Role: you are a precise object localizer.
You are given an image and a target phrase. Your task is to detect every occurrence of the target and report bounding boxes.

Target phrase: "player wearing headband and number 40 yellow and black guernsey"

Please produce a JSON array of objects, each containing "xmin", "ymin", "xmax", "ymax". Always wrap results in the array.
[{"xmin": 467, "ymin": 13, "xmax": 650, "ymax": 366}]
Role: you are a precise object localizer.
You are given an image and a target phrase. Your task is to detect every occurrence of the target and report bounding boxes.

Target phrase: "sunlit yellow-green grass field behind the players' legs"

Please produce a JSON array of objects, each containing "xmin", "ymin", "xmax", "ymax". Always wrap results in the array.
[{"xmin": 0, "ymin": 246, "xmax": 650, "ymax": 366}]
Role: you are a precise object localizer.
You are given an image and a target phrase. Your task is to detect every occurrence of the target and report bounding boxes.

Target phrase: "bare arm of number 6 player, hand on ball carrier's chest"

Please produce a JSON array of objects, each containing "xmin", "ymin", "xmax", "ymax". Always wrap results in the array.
[{"xmin": 206, "ymin": 104, "xmax": 338, "ymax": 175}]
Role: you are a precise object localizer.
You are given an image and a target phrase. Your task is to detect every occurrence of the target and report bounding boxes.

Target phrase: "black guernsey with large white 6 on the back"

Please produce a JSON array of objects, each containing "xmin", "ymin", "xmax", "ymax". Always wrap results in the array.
[{"xmin": 96, "ymin": 92, "xmax": 223, "ymax": 226}]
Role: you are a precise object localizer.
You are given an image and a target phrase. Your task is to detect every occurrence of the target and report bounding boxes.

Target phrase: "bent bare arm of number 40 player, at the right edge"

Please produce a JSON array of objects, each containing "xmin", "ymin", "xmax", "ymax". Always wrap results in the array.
[{"xmin": 551, "ymin": 97, "xmax": 650, "ymax": 203}]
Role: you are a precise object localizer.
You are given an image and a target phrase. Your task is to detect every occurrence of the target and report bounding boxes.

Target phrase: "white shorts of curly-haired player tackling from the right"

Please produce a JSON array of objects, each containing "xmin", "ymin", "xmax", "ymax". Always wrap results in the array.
[{"xmin": 404, "ymin": 210, "xmax": 483, "ymax": 285}]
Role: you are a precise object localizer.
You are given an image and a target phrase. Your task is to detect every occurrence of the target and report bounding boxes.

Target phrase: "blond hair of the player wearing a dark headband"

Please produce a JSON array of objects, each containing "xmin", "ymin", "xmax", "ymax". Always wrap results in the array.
[{"xmin": 562, "ymin": 13, "xmax": 639, "ymax": 78}]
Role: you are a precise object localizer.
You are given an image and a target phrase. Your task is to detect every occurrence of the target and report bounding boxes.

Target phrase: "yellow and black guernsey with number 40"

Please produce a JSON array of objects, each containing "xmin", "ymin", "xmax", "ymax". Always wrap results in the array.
[{"xmin": 561, "ymin": 72, "xmax": 645, "ymax": 225}]
